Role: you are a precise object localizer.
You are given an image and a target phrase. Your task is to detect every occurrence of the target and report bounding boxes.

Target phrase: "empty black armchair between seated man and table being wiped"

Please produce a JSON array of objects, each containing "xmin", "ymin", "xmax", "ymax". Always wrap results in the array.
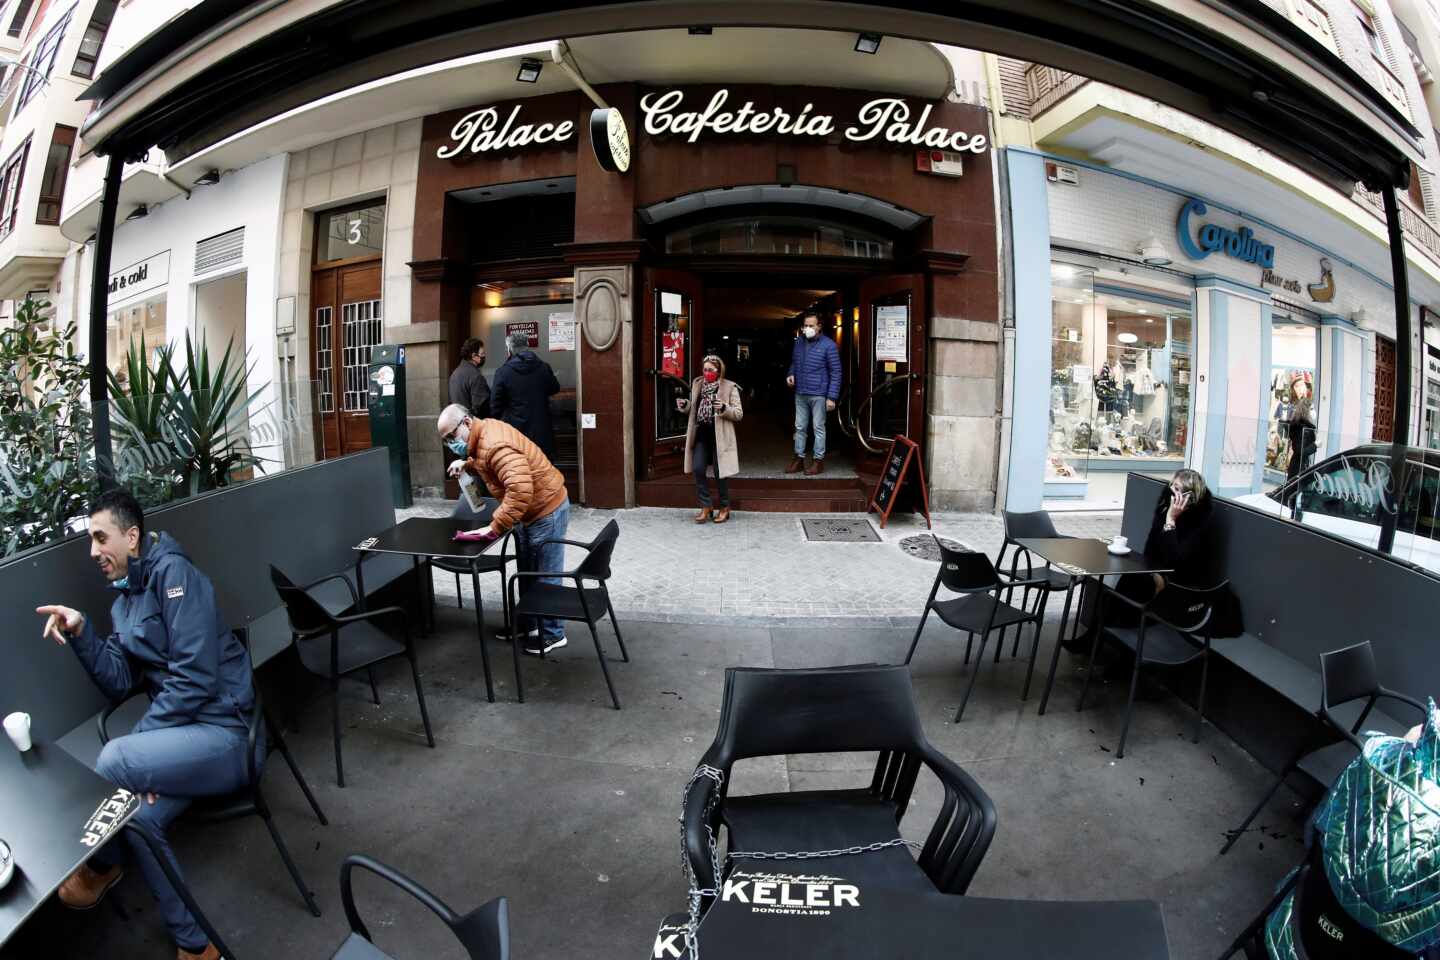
[{"xmin": 271, "ymin": 564, "xmax": 435, "ymax": 787}]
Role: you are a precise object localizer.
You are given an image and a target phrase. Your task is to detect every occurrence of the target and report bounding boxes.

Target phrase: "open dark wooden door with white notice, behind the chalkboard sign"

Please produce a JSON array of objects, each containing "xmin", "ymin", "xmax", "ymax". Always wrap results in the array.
[{"xmin": 855, "ymin": 273, "xmax": 926, "ymax": 474}]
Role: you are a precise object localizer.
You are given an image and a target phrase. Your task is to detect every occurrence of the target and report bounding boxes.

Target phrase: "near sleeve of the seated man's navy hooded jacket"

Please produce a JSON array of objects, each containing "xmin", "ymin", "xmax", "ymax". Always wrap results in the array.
[{"xmin": 135, "ymin": 561, "xmax": 220, "ymax": 733}]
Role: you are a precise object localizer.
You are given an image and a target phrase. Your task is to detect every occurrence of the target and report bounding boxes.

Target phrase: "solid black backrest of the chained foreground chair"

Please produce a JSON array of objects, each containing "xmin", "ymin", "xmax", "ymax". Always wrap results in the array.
[{"xmin": 713, "ymin": 664, "xmax": 929, "ymax": 767}]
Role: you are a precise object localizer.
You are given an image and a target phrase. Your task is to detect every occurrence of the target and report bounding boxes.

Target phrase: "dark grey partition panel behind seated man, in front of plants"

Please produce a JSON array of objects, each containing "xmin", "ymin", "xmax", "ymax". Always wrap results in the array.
[{"xmin": 0, "ymin": 448, "xmax": 395, "ymax": 740}]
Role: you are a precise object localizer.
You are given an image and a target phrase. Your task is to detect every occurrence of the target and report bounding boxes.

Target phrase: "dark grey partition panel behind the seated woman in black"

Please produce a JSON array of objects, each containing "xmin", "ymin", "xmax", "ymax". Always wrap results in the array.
[{"xmin": 1123, "ymin": 474, "xmax": 1440, "ymax": 770}]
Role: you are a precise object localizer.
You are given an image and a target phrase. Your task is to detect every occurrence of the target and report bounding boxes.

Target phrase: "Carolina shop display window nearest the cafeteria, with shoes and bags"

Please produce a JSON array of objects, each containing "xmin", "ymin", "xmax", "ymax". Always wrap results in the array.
[{"xmin": 1045, "ymin": 263, "xmax": 1192, "ymax": 484}]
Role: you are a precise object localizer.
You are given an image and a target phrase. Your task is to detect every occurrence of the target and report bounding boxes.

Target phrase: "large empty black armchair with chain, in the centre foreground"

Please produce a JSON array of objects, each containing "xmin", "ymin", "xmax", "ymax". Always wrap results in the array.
[{"xmin": 681, "ymin": 664, "xmax": 995, "ymax": 908}]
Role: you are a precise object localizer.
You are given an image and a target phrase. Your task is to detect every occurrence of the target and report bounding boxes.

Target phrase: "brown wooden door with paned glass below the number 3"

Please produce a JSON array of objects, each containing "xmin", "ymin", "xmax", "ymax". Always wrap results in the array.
[{"xmin": 310, "ymin": 259, "xmax": 384, "ymax": 459}]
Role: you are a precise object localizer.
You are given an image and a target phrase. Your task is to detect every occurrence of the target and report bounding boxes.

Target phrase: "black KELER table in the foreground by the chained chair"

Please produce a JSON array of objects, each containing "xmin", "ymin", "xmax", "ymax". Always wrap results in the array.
[{"xmin": 673, "ymin": 861, "xmax": 1169, "ymax": 960}]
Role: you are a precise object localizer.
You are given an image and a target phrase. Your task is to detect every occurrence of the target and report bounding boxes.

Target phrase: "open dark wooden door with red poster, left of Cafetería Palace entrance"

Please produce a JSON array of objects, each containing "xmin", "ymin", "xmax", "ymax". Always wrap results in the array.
[{"xmin": 638, "ymin": 269, "xmax": 704, "ymax": 479}]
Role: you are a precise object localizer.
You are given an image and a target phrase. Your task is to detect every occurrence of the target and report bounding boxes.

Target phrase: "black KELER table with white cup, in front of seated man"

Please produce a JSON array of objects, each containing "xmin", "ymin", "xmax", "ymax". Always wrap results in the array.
[{"xmin": 0, "ymin": 738, "xmax": 140, "ymax": 944}]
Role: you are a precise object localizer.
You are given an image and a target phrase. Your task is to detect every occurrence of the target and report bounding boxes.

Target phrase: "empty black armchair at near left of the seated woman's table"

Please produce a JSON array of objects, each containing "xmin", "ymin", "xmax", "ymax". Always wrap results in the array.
[{"xmin": 904, "ymin": 537, "xmax": 1050, "ymax": 723}]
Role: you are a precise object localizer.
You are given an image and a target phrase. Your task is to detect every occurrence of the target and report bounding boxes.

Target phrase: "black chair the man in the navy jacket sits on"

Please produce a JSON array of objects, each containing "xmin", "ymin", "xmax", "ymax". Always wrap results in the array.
[{"xmin": 105, "ymin": 630, "xmax": 330, "ymax": 957}]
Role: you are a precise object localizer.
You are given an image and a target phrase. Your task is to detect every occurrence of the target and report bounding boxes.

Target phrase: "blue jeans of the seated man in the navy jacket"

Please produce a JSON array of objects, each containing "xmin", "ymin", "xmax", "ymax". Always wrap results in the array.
[{"xmin": 91, "ymin": 724, "xmax": 265, "ymax": 953}]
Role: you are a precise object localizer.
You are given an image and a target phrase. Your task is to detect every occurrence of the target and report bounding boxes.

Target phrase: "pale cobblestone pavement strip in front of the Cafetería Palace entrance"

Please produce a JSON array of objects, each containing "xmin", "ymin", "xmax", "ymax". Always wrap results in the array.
[{"xmin": 399, "ymin": 499, "xmax": 1120, "ymax": 626}]
